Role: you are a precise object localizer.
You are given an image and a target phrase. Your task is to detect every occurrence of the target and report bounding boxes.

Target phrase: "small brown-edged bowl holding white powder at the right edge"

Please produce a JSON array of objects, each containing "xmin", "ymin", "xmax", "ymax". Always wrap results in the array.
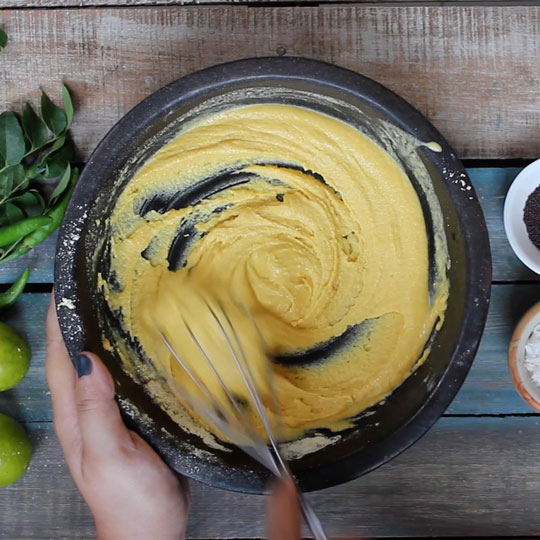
[{"xmin": 508, "ymin": 302, "xmax": 540, "ymax": 412}]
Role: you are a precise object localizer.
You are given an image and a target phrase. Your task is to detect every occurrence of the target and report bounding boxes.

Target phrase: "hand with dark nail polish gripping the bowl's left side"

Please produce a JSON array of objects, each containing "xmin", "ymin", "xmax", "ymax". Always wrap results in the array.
[{"xmin": 46, "ymin": 297, "xmax": 190, "ymax": 540}]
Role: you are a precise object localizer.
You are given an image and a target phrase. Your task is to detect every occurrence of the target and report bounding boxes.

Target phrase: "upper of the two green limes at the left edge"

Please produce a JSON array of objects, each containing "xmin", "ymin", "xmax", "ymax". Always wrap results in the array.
[{"xmin": 0, "ymin": 322, "xmax": 30, "ymax": 392}]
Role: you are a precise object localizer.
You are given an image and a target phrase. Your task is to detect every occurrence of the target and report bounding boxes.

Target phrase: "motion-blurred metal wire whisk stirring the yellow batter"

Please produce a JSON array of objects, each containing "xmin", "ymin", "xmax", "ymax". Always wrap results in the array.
[{"xmin": 157, "ymin": 298, "xmax": 327, "ymax": 540}]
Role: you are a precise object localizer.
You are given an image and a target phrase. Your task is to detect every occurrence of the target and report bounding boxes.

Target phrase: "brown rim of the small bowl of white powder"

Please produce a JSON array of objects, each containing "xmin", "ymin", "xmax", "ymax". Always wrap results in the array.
[{"xmin": 508, "ymin": 302, "xmax": 540, "ymax": 412}]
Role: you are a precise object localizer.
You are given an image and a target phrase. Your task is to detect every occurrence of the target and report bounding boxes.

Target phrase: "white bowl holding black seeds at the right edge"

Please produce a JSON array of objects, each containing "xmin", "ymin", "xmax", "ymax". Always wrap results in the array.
[{"xmin": 504, "ymin": 159, "xmax": 540, "ymax": 274}]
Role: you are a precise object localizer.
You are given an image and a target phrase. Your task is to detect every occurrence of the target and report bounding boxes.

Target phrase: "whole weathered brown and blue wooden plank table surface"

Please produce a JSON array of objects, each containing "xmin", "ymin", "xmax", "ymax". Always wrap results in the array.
[{"xmin": 0, "ymin": 0, "xmax": 540, "ymax": 540}]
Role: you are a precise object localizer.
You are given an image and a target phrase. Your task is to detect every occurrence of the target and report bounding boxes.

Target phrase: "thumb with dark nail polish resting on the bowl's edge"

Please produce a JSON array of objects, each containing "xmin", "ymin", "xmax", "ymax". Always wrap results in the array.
[{"xmin": 74, "ymin": 352, "xmax": 134, "ymax": 459}]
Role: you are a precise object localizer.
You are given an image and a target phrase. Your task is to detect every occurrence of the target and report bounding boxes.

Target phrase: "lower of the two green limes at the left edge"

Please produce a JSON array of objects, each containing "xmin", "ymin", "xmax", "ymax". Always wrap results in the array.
[{"xmin": 0, "ymin": 414, "xmax": 32, "ymax": 487}]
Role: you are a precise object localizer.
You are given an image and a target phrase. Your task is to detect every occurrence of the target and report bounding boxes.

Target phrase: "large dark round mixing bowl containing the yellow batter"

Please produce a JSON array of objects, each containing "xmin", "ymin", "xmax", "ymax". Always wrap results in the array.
[{"xmin": 55, "ymin": 58, "xmax": 491, "ymax": 493}]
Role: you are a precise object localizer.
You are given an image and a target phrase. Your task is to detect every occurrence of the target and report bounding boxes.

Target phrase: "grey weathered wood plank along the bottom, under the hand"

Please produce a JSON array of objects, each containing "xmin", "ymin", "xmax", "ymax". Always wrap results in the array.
[{"xmin": 0, "ymin": 417, "xmax": 540, "ymax": 540}]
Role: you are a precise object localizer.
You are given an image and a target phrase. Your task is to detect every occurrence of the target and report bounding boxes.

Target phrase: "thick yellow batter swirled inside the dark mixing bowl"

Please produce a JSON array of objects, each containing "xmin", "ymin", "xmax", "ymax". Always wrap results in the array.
[{"xmin": 102, "ymin": 104, "xmax": 448, "ymax": 439}]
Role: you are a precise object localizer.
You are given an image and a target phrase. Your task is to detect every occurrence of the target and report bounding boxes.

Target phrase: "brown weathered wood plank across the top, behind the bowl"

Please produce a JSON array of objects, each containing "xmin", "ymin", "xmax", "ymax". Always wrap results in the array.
[{"xmin": 0, "ymin": 5, "xmax": 540, "ymax": 158}]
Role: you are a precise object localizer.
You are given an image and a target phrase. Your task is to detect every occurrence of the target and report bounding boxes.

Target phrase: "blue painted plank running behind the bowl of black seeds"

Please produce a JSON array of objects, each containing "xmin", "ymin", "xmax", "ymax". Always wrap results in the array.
[{"xmin": 0, "ymin": 168, "xmax": 540, "ymax": 283}]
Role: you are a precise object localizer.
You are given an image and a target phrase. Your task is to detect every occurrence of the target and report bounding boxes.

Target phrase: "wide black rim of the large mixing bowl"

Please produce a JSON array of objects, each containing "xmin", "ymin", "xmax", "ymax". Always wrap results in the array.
[{"xmin": 55, "ymin": 57, "xmax": 491, "ymax": 493}]
